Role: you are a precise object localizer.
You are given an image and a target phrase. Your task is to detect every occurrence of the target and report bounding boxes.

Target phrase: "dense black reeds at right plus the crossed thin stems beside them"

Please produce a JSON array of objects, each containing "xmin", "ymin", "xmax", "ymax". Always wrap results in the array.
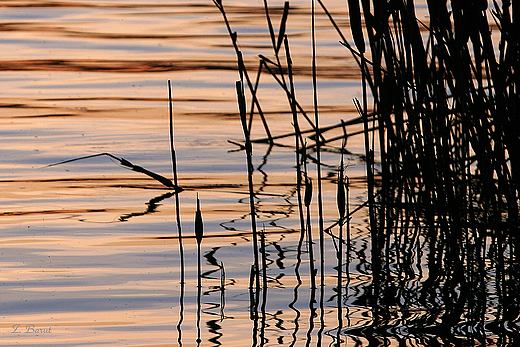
[{"xmin": 214, "ymin": 0, "xmax": 520, "ymax": 344}]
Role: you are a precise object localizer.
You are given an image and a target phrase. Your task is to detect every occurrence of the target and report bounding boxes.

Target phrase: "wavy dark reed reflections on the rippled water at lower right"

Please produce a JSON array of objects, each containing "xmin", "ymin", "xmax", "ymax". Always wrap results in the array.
[{"xmin": 178, "ymin": 142, "xmax": 520, "ymax": 347}]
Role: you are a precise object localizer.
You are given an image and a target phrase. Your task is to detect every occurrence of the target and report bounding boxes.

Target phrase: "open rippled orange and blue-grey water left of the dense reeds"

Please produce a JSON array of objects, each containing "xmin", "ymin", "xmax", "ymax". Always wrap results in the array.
[{"xmin": 0, "ymin": 0, "xmax": 512, "ymax": 346}]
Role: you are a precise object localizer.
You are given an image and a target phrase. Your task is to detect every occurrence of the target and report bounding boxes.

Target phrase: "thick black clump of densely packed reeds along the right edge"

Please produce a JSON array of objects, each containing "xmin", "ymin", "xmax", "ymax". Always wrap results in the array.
[{"xmin": 349, "ymin": 0, "xmax": 520, "ymax": 335}]
